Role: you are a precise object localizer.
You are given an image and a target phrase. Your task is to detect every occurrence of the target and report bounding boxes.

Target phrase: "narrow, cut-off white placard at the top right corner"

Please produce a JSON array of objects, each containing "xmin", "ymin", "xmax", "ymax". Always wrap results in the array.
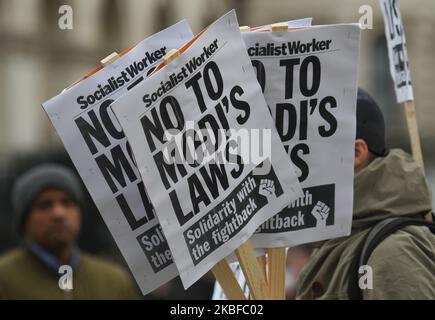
[{"xmin": 379, "ymin": 0, "xmax": 414, "ymax": 103}]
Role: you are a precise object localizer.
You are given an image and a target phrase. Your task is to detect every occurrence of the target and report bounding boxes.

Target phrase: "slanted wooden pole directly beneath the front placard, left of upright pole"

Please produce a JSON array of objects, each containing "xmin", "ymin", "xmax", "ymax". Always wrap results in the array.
[{"xmin": 236, "ymin": 240, "xmax": 270, "ymax": 300}]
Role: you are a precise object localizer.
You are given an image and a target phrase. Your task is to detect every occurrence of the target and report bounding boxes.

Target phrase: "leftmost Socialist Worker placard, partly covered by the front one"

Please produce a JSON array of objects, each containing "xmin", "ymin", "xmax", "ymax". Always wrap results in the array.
[{"xmin": 43, "ymin": 21, "xmax": 193, "ymax": 294}]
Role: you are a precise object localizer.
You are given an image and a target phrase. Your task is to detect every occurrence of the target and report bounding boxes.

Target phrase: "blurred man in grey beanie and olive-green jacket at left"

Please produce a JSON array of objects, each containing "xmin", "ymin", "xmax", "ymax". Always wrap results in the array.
[{"xmin": 0, "ymin": 164, "xmax": 137, "ymax": 299}]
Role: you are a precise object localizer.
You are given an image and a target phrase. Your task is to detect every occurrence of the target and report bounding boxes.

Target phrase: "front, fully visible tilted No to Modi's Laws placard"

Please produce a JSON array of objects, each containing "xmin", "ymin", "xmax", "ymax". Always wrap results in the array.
[{"xmin": 112, "ymin": 10, "xmax": 302, "ymax": 288}]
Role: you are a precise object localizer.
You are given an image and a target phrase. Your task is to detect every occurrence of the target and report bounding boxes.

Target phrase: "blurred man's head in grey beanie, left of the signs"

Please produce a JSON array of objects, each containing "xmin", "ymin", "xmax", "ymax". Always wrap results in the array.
[{"xmin": 12, "ymin": 164, "xmax": 83, "ymax": 252}]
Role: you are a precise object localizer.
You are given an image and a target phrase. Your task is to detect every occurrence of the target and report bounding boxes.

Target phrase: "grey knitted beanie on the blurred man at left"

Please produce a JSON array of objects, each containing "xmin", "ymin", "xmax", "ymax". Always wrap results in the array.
[{"xmin": 12, "ymin": 164, "xmax": 83, "ymax": 234}]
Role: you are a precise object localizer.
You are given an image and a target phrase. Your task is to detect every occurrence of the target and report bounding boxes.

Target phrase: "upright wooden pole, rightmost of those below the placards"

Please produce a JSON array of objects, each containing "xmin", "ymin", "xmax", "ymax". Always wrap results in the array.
[{"xmin": 267, "ymin": 248, "xmax": 286, "ymax": 300}]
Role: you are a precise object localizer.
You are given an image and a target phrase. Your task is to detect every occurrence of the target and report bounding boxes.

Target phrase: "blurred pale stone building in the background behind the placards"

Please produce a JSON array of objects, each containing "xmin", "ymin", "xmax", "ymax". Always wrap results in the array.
[{"xmin": 0, "ymin": 0, "xmax": 435, "ymax": 298}]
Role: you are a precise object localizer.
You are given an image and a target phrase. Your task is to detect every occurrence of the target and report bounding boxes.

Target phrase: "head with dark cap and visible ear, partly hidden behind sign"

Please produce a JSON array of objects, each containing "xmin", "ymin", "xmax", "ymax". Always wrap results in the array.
[{"xmin": 355, "ymin": 88, "xmax": 386, "ymax": 172}]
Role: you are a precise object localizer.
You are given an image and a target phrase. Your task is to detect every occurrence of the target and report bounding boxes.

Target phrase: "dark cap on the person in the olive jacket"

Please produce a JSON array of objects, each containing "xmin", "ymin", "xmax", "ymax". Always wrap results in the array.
[{"xmin": 356, "ymin": 88, "xmax": 387, "ymax": 157}]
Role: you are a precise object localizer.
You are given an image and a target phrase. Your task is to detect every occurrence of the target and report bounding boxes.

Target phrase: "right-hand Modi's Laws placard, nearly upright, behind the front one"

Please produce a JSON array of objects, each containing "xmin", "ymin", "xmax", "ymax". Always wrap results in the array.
[{"xmin": 242, "ymin": 24, "xmax": 360, "ymax": 248}]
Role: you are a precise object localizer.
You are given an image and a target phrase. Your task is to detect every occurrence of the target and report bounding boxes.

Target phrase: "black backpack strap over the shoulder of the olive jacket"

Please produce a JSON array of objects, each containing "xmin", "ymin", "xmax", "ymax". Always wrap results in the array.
[{"xmin": 348, "ymin": 217, "xmax": 435, "ymax": 300}]
